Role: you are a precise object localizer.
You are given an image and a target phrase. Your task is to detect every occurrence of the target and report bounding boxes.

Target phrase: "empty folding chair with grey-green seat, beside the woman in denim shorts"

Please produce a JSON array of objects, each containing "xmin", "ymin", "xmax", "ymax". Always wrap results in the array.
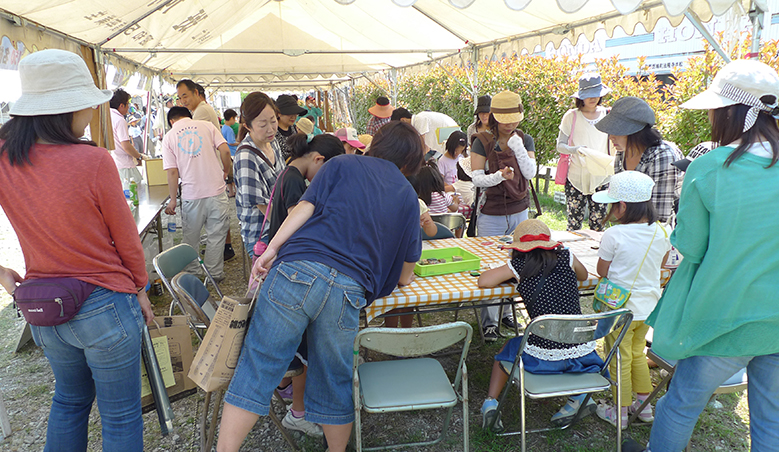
[{"xmin": 353, "ymin": 322, "xmax": 473, "ymax": 452}]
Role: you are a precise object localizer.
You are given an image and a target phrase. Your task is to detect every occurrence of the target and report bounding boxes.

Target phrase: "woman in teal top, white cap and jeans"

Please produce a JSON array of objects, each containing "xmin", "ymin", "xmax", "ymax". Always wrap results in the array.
[{"xmin": 623, "ymin": 60, "xmax": 779, "ymax": 452}]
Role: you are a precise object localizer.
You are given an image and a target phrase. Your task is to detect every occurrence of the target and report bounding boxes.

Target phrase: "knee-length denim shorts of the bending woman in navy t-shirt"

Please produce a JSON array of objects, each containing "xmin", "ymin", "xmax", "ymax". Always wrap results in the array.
[{"xmin": 225, "ymin": 261, "xmax": 367, "ymax": 425}]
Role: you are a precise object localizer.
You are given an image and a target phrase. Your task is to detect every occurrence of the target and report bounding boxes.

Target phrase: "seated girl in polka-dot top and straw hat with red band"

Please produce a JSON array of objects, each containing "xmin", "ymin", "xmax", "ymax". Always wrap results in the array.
[{"xmin": 479, "ymin": 220, "xmax": 603, "ymax": 431}]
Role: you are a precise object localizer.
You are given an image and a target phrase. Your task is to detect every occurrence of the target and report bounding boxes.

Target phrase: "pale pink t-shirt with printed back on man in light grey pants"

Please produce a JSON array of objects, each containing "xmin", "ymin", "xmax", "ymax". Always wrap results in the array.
[{"xmin": 162, "ymin": 118, "xmax": 227, "ymax": 199}]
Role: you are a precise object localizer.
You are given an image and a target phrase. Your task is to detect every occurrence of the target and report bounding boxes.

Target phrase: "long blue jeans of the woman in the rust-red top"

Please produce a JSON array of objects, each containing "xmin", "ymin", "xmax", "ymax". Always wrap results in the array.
[{"xmin": 31, "ymin": 287, "xmax": 143, "ymax": 452}]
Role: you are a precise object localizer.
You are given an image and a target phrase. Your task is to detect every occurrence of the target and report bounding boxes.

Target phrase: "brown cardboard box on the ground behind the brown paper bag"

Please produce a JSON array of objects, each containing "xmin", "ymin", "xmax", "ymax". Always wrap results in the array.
[{"xmin": 141, "ymin": 315, "xmax": 197, "ymax": 413}]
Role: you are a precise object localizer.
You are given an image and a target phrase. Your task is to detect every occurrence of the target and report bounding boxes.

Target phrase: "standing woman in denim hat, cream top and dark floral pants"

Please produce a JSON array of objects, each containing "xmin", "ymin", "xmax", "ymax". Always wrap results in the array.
[{"xmin": 557, "ymin": 73, "xmax": 611, "ymax": 231}]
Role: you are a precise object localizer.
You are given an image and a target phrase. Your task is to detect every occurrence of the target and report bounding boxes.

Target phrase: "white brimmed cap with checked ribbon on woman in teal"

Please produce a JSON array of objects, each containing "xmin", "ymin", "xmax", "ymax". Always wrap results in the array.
[{"xmin": 680, "ymin": 60, "xmax": 779, "ymax": 132}]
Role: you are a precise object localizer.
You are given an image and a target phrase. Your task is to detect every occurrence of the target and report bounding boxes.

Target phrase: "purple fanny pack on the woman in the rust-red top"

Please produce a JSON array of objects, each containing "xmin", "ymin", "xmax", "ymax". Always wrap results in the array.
[{"xmin": 13, "ymin": 278, "xmax": 97, "ymax": 326}]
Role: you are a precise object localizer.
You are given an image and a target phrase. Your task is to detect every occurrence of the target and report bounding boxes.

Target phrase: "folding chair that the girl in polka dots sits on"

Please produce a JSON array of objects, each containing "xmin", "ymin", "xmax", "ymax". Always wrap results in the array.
[{"xmin": 489, "ymin": 309, "xmax": 633, "ymax": 452}]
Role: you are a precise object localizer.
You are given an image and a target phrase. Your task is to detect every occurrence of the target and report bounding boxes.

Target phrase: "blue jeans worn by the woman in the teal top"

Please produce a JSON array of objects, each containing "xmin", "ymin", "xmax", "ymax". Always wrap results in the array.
[{"xmin": 647, "ymin": 353, "xmax": 779, "ymax": 452}]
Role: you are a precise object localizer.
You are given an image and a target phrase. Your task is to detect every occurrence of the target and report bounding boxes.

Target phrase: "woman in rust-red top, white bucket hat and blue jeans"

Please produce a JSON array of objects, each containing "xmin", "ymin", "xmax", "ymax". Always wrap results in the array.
[{"xmin": 0, "ymin": 49, "xmax": 154, "ymax": 452}]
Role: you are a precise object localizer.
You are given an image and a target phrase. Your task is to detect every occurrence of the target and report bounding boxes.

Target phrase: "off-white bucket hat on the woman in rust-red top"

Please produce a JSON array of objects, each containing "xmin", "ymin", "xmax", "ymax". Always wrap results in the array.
[{"xmin": 10, "ymin": 49, "xmax": 114, "ymax": 116}]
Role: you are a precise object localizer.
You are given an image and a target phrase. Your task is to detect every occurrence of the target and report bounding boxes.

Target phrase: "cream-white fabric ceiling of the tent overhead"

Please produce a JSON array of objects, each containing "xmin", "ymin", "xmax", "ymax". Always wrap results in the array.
[{"xmin": 0, "ymin": 0, "xmax": 766, "ymax": 86}]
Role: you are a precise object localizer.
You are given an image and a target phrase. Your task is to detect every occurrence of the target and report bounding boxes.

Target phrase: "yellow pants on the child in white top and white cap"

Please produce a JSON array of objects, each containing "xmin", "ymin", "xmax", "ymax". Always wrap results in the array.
[{"xmin": 604, "ymin": 321, "xmax": 654, "ymax": 406}]
